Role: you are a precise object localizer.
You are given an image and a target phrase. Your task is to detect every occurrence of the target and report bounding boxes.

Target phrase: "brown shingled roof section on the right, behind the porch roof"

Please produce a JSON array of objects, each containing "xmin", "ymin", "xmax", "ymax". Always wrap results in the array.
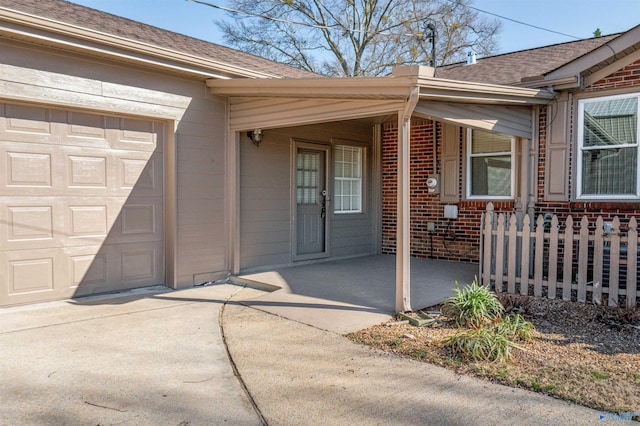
[{"xmin": 436, "ymin": 34, "xmax": 619, "ymax": 85}]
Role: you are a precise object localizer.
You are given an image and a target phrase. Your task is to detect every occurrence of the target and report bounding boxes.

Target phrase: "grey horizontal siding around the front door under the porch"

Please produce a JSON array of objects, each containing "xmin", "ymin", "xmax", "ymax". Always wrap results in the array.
[{"xmin": 240, "ymin": 123, "xmax": 374, "ymax": 269}]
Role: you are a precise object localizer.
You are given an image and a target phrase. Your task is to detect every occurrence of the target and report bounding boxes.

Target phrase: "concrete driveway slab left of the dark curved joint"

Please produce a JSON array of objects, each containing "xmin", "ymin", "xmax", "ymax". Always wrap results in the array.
[{"xmin": 0, "ymin": 284, "xmax": 261, "ymax": 425}]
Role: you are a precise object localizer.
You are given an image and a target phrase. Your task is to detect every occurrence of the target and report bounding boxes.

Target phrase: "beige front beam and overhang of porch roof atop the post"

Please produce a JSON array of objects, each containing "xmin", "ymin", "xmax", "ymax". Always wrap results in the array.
[{"xmin": 207, "ymin": 67, "xmax": 553, "ymax": 138}]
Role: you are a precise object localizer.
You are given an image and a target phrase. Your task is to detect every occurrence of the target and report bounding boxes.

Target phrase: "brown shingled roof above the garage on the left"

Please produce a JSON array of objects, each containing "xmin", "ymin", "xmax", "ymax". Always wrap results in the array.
[{"xmin": 0, "ymin": 0, "xmax": 318, "ymax": 78}]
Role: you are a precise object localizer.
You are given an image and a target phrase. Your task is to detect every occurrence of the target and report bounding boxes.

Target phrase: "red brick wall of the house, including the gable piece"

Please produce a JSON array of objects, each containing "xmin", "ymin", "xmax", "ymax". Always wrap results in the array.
[{"xmin": 382, "ymin": 61, "xmax": 640, "ymax": 262}]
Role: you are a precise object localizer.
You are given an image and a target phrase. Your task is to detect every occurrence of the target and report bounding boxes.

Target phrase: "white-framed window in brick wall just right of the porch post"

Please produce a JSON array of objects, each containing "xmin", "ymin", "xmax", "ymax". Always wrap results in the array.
[{"xmin": 467, "ymin": 130, "xmax": 515, "ymax": 199}]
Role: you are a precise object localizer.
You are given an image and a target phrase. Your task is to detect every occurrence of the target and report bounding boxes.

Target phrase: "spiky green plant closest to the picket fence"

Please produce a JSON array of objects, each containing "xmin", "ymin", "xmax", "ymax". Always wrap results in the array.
[{"xmin": 442, "ymin": 278, "xmax": 504, "ymax": 328}]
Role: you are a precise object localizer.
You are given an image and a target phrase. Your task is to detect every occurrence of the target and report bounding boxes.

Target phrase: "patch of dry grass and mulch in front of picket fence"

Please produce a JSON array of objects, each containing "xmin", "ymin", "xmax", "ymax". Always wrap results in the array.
[{"xmin": 348, "ymin": 296, "xmax": 640, "ymax": 419}]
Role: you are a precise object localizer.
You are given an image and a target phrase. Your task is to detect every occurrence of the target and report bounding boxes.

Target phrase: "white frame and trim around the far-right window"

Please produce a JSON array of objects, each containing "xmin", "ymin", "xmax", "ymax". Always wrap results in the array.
[{"xmin": 575, "ymin": 93, "xmax": 640, "ymax": 201}]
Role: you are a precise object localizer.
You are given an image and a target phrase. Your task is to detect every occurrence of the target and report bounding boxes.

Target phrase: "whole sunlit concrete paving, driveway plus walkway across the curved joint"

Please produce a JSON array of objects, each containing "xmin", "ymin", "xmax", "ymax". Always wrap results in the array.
[{"xmin": 0, "ymin": 284, "xmax": 601, "ymax": 426}]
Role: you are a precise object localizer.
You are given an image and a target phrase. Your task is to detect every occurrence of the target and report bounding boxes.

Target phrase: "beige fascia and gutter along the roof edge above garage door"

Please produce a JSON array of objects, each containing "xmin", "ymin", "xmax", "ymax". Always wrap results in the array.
[{"xmin": 0, "ymin": 7, "xmax": 277, "ymax": 78}]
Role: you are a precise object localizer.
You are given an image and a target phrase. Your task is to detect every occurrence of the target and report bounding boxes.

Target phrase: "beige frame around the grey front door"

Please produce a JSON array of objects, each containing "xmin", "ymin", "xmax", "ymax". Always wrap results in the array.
[{"xmin": 290, "ymin": 139, "xmax": 333, "ymax": 262}]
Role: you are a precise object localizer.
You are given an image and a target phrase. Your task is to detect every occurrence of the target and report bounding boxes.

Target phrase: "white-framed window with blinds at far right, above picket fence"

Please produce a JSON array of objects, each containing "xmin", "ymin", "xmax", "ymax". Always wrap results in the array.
[{"xmin": 577, "ymin": 95, "xmax": 640, "ymax": 198}]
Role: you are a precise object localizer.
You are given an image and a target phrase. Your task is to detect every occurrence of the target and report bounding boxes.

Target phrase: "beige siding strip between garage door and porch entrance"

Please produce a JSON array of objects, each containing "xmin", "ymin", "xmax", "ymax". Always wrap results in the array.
[{"xmin": 176, "ymin": 92, "xmax": 229, "ymax": 285}]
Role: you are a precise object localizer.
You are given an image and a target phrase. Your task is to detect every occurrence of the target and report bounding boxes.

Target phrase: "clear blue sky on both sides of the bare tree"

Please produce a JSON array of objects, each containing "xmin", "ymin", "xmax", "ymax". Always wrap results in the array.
[{"xmin": 70, "ymin": 0, "xmax": 640, "ymax": 54}]
